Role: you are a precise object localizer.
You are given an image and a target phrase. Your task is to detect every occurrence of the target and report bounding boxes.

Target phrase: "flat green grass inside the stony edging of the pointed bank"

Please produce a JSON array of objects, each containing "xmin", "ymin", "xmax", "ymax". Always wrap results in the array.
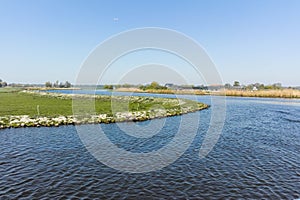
[{"xmin": 0, "ymin": 89, "xmax": 204, "ymax": 117}]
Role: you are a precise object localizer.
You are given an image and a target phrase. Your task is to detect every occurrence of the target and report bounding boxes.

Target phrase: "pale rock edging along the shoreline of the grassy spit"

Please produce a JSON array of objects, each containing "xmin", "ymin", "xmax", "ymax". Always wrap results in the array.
[{"xmin": 0, "ymin": 91, "xmax": 209, "ymax": 129}]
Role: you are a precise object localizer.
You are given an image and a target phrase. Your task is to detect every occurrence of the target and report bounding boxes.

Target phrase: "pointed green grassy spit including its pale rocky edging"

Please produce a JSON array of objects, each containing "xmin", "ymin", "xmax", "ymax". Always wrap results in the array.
[{"xmin": 0, "ymin": 90, "xmax": 209, "ymax": 129}]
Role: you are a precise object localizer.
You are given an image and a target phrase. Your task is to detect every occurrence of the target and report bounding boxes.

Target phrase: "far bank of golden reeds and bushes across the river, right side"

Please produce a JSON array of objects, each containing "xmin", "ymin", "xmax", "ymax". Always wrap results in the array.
[{"xmin": 108, "ymin": 81, "xmax": 300, "ymax": 98}]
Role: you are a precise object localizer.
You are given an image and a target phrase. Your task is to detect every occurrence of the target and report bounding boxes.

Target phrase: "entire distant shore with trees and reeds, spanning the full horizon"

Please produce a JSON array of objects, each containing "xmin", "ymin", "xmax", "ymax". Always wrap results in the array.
[{"xmin": 0, "ymin": 79, "xmax": 300, "ymax": 98}]
